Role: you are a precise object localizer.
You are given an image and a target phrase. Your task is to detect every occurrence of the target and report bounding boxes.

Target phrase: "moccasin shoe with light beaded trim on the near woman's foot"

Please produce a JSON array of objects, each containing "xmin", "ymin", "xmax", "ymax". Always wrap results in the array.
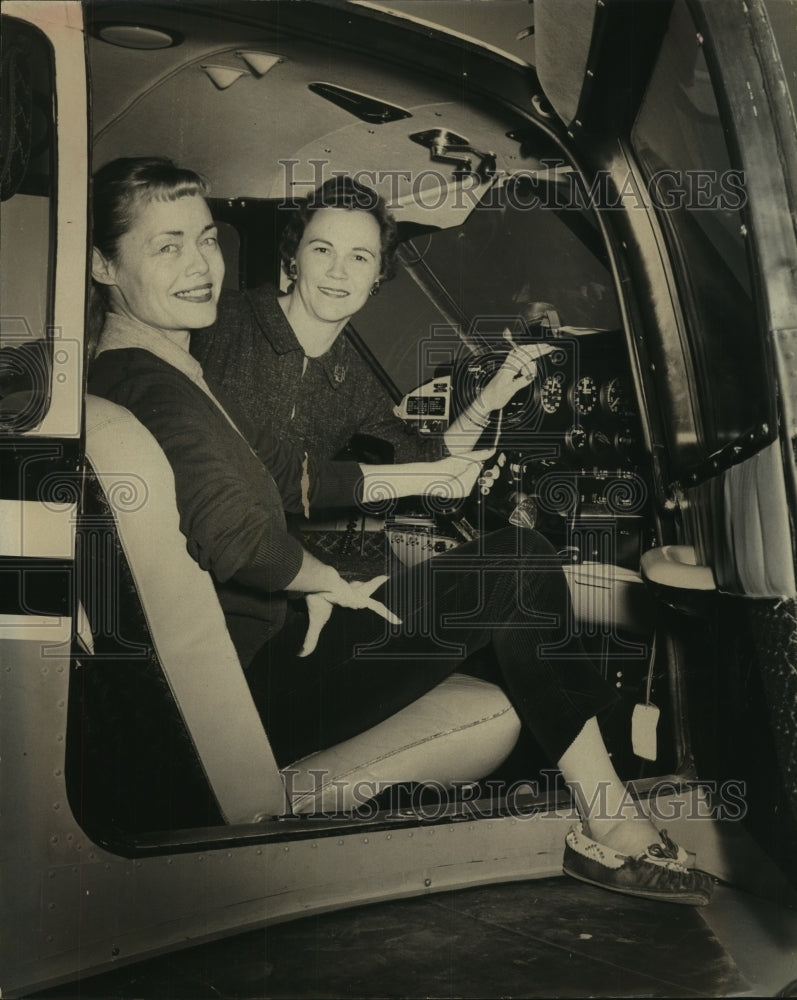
[{"xmin": 562, "ymin": 824, "xmax": 714, "ymax": 906}]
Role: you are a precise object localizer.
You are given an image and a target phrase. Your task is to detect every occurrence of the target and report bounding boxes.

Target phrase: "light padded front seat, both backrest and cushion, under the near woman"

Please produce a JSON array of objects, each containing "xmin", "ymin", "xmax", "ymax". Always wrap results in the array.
[{"xmin": 86, "ymin": 396, "xmax": 520, "ymax": 823}]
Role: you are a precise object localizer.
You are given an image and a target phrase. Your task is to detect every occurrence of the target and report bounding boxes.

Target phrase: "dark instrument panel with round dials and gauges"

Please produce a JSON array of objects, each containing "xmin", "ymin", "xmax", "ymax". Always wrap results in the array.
[{"xmin": 390, "ymin": 330, "xmax": 647, "ymax": 569}]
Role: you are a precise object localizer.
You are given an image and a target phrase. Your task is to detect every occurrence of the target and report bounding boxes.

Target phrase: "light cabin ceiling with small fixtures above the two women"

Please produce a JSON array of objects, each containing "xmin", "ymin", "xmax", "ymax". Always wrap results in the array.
[{"xmin": 90, "ymin": 3, "xmax": 537, "ymax": 213}]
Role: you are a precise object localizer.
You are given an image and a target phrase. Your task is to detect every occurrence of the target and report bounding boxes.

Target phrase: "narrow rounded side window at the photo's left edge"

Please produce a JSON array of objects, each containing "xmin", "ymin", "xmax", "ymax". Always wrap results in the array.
[{"xmin": 0, "ymin": 17, "xmax": 55, "ymax": 430}]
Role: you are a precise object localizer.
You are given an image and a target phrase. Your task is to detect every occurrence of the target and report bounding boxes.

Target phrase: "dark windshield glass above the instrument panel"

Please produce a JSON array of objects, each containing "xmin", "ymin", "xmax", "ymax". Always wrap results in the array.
[{"xmin": 355, "ymin": 175, "xmax": 620, "ymax": 395}]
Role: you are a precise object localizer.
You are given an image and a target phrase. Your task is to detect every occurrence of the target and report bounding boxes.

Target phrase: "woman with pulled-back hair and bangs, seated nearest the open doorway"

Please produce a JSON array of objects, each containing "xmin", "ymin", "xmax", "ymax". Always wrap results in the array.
[{"xmin": 89, "ymin": 159, "xmax": 711, "ymax": 904}]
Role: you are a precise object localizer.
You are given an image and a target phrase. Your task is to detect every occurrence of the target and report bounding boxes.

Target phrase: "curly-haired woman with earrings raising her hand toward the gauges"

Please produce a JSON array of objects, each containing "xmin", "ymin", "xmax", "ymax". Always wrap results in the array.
[{"xmin": 191, "ymin": 176, "xmax": 550, "ymax": 472}]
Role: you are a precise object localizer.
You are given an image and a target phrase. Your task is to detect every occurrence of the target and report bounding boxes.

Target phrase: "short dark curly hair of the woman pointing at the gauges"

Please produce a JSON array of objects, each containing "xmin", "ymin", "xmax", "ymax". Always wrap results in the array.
[{"xmin": 279, "ymin": 175, "xmax": 398, "ymax": 281}]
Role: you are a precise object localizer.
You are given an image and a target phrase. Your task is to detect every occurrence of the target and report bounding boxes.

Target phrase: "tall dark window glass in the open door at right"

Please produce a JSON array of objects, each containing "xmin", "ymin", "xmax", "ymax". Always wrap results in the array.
[{"xmin": 632, "ymin": 0, "xmax": 769, "ymax": 458}]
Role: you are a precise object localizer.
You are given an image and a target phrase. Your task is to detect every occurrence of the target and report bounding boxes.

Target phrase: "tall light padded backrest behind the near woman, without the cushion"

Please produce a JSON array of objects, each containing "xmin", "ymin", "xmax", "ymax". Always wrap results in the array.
[{"xmin": 86, "ymin": 396, "xmax": 286, "ymax": 823}]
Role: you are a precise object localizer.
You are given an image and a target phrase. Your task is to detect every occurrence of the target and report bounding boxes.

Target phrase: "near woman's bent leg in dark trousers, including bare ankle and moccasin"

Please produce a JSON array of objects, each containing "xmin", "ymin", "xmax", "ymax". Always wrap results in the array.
[{"xmin": 250, "ymin": 529, "xmax": 712, "ymax": 905}]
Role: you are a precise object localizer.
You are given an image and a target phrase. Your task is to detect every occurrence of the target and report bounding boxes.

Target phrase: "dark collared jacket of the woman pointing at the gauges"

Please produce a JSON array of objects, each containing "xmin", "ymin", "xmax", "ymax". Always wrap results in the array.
[{"xmin": 191, "ymin": 285, "xmax": 442, "ymax": 462}]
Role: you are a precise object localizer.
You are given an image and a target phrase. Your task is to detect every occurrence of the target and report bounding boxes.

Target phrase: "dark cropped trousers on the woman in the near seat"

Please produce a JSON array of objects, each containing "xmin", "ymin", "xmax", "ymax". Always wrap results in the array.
[{"xmin": 255, "ymin": 528, "xmax": 616, "ymax": 764}]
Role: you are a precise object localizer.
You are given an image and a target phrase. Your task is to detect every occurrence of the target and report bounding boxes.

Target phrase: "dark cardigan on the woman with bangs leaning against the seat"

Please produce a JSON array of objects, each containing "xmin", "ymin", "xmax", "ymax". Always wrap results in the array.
[{"xmin": 88, "ymin": 348, "xmax": 361, "ymax": 666}]
